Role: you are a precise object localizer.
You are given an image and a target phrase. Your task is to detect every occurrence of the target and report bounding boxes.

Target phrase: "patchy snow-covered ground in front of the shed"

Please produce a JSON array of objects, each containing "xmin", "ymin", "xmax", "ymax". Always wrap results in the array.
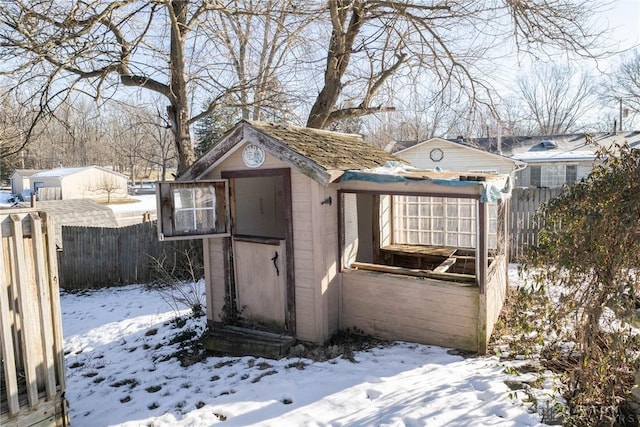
[{"xmin": 61, "ymin": 269, "xmax": 552, "ymax": 427}]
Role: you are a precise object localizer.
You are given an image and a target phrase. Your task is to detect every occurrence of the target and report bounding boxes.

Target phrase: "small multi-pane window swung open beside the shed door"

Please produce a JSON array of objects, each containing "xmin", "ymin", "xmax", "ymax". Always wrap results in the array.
[{"xmin": 157, "ymin": 180, "xmax": 230, "ymax": 240}]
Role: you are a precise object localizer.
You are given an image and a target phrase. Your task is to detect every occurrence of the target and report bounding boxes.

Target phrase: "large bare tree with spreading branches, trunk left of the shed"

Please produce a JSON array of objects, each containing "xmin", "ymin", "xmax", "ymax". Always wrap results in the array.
[{"xmin": 0, "ymin": 0, "xmax": 310, "ymax": 172}]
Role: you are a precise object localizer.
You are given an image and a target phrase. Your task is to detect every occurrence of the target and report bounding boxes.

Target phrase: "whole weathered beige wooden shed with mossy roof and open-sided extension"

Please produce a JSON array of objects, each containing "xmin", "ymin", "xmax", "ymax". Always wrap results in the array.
[{"xmin": 158, "ymin": 121, "xmax": 510, "ymax": 352}]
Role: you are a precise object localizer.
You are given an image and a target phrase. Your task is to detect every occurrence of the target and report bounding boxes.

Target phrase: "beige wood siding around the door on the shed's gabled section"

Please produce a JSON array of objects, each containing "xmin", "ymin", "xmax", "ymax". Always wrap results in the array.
[{"xmin": 202, "ymin": 144, "xmax": 340, "ymax": 342}]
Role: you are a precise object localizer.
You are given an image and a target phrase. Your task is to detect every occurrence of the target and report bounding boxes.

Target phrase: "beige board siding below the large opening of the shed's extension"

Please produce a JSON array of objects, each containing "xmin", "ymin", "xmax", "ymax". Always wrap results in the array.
[{"xmin": 342, "ymin": 270, "xmax": 479, "ymax": 351}]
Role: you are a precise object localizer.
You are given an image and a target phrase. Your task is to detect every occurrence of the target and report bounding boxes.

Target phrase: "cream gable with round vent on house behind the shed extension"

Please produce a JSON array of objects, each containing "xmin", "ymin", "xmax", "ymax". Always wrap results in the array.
[{"xmin": 394, "ymin": 138, "xmax": 526, "ymax": 178}]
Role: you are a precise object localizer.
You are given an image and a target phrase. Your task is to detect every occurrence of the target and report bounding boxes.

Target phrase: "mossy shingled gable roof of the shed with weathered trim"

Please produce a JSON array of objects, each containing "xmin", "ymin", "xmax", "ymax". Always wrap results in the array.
[{"xmin": 179, "ymin": 120, "xmax": 406, "ymax": 185}]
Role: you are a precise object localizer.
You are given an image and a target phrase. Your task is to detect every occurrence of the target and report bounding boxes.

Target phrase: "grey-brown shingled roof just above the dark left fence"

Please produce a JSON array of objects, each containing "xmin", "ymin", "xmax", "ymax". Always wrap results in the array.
[{"xmin": 20, "ymin": 199, "xmax": 118, "ymax": 247}]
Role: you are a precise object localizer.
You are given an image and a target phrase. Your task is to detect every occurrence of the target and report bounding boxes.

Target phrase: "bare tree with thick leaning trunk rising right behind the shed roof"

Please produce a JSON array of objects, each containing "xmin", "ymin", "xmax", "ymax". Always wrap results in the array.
[{"xmin": 307, "ymin": 0, "xmax": 607, "ymax": 128}]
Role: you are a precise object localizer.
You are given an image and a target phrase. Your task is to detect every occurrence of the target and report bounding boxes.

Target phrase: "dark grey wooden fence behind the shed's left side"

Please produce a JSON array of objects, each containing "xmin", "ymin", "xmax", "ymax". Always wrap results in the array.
[{"xmin": 58, "ymin": 222, "xmax": 202, "ymax": 289}]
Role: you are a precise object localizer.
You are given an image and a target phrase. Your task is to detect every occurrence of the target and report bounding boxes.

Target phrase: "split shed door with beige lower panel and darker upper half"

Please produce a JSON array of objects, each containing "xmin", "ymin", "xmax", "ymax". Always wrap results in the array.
[{"xmin": 223, "ymin": 169, "xmax": 295, "ymax": 334}]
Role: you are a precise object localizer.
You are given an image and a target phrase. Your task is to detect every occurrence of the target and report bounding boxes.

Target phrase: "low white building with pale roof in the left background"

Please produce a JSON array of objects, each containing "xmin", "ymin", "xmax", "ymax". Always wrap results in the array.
[{"xmin": 30, "ymin": 166, "xmax": 127, "ymax": 200}]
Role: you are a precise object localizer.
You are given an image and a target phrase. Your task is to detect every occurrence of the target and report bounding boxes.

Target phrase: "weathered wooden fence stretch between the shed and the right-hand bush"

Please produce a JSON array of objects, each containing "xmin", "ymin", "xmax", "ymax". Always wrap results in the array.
[{"xmin": 509, "ymin": 188, "xmax": 563, "ymax": 261}]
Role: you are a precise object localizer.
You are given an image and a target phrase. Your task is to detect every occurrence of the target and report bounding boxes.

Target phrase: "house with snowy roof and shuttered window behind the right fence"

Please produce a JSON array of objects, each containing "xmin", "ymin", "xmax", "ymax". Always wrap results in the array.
[{"xmin": 464, "ymin": 131, "xmax": 640, "ymax": 188}]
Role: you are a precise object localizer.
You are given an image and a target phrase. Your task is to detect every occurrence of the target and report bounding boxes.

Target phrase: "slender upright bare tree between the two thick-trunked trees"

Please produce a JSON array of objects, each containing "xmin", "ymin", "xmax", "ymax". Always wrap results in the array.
[{"xmin": 203, "ymin": 0, "xmax": 319, "ymax": 121}]
